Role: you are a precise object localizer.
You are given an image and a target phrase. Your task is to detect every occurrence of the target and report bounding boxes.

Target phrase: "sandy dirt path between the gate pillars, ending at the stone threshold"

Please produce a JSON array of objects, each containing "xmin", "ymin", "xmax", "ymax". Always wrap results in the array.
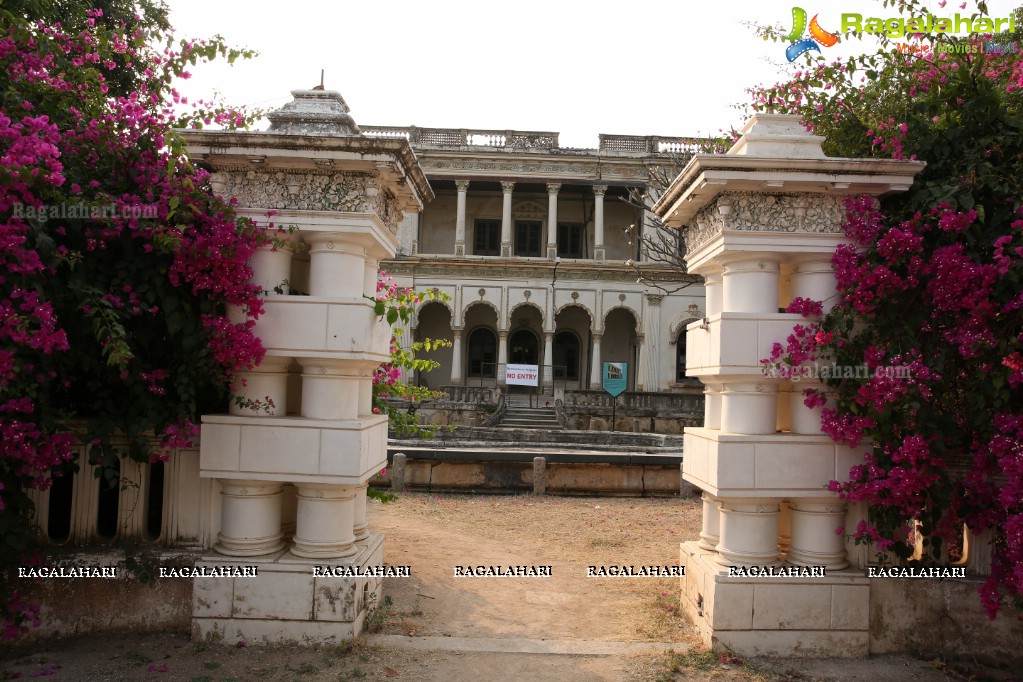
[{"xmin": 370, "ymin": 496, "xmax": 699, "ymax": 645}]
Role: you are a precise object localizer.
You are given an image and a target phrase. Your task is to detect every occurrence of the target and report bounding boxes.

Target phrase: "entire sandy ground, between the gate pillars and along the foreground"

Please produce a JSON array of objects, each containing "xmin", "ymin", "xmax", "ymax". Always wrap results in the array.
[{"xmin": 0, "ymin": 494, "xmax": 990, "ymax": 682}]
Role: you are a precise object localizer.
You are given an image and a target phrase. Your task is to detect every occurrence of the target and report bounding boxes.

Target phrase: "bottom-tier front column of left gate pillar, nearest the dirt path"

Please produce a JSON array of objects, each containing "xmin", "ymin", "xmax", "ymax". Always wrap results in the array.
[{"xmin": 292, "ymin": 483, "xmax": 356, "ymax": 559}]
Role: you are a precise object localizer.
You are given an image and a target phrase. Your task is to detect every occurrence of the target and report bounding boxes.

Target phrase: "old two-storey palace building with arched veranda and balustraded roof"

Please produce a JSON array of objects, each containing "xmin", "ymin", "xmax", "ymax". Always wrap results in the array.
[{"xmin": 361, "ymin": 126, "xmax": 704, "ymax": 392}]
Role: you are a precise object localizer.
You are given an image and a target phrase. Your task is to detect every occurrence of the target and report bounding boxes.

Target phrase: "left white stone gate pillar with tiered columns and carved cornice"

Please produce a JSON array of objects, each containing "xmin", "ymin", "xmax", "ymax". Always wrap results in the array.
[{"xmin": 185, "ymin": 91, "xmax": 433, "ymax": 641}]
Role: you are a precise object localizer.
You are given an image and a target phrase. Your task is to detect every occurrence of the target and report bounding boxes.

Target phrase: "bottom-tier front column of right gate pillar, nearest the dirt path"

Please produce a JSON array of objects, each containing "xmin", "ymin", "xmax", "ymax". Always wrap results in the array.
[{"xmin": 716, "ymin": 497, "xmax": 780, "ymax": 565}]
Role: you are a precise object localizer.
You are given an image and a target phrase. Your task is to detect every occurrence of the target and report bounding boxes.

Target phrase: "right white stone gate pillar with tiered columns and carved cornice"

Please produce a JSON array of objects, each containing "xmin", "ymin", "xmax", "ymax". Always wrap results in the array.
[{"xmin": 654, "ymin": 115, "xmax": 923, "ymax": 656}]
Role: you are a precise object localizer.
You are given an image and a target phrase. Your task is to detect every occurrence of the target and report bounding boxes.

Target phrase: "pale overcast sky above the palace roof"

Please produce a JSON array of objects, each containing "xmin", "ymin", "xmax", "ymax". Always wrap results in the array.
[{"xmin": 163, "ymin": 0, "xmax": 1023, "ymax": 147}]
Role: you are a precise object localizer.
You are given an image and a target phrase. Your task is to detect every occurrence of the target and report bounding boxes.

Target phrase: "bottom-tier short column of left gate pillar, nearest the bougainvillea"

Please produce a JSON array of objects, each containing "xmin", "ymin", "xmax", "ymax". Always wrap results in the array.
[{"xmin": 214, "ymin": 480, "xmax": 284, "ymax": 556}]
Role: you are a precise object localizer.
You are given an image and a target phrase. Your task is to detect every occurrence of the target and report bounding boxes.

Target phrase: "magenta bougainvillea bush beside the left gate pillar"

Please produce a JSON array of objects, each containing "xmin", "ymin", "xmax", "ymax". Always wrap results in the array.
[{"xmin": 0, "ymin": 2, "xmax": 264, "ymax": 637}]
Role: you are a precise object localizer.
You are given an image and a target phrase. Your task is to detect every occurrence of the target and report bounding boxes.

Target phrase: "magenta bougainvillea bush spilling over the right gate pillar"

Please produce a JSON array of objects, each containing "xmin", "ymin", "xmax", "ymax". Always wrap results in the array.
[{"xmin": 754, "ymin": 2, "xmax": 1023, "ymax": 618}]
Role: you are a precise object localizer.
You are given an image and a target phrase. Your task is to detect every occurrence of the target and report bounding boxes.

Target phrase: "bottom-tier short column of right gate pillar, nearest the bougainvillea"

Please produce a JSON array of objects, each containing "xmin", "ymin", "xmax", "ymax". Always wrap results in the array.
[{"xmin": 787, "ymin": 498, "xmax": 849, "ymax": 571}]
